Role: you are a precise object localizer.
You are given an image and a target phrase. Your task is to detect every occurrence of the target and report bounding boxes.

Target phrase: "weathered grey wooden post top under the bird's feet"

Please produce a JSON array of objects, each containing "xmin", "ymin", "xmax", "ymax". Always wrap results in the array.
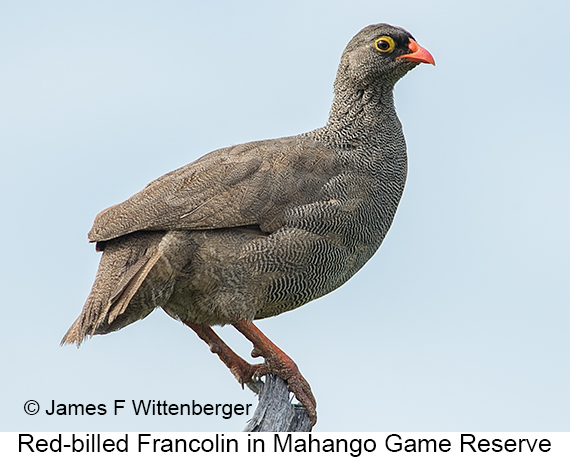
[{"xmin": 243, "ymin": 374, "xmax": 312, "ymax": 432}]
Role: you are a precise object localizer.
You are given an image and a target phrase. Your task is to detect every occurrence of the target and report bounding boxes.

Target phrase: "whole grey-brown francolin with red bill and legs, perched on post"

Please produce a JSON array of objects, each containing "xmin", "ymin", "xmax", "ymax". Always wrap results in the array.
[{"xmin": 61, "ymin": 23, "xmax": 435, "ymax": 425}]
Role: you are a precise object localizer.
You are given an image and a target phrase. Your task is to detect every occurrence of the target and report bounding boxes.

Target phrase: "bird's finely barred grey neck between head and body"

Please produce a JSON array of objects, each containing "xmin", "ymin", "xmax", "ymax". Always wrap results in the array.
[{"xmin": 304, "ymin": 81, "xmax": 401, "ymax": 147}]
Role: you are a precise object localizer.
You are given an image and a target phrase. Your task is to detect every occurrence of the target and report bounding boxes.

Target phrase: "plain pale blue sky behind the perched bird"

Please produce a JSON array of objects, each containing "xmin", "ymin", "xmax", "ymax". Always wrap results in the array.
[{"xmin": 0, "ymin": 0, "xmax": 570, "ymax": 431}]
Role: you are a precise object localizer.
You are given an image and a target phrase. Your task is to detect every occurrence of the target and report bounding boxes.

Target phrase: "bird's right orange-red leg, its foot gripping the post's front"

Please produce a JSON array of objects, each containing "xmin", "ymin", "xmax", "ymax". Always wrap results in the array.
[{"xmin": 232, "ymin": 319, "xmax": 317, "ymax": 426}]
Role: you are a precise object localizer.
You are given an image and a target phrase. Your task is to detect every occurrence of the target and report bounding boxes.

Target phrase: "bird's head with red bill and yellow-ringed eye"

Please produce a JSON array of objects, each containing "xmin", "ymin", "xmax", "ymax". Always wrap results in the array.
[{"xmin": 339, "ymin": 24, "xmax": 435, "ymax": 89}]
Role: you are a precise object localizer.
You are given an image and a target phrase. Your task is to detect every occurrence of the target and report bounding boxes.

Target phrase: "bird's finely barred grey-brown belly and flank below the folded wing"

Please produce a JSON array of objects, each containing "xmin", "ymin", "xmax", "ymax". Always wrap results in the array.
[{"xmin": 153, "ymin": 186, "xmax": 395, "ymax": 325}]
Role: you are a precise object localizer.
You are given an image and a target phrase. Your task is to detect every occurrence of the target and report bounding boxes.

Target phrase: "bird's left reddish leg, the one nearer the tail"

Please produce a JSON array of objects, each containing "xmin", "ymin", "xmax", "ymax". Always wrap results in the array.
[{"xmin": 182, "ymin": 321, "xmax": 269, "ymax": 390}]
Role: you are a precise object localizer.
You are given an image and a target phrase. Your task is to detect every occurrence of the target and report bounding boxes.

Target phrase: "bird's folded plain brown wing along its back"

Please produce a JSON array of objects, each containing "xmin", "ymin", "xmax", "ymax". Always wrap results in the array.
[{"xmin": 88, "ymin": 137, "xmax": 338, "ymax": 242}]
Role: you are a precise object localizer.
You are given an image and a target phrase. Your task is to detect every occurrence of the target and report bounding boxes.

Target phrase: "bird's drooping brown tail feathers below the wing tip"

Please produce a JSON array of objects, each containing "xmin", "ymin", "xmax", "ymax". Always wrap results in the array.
[{"xmin": 61, "ymin": 232, "xmax": 164, "ymax": 346}]
